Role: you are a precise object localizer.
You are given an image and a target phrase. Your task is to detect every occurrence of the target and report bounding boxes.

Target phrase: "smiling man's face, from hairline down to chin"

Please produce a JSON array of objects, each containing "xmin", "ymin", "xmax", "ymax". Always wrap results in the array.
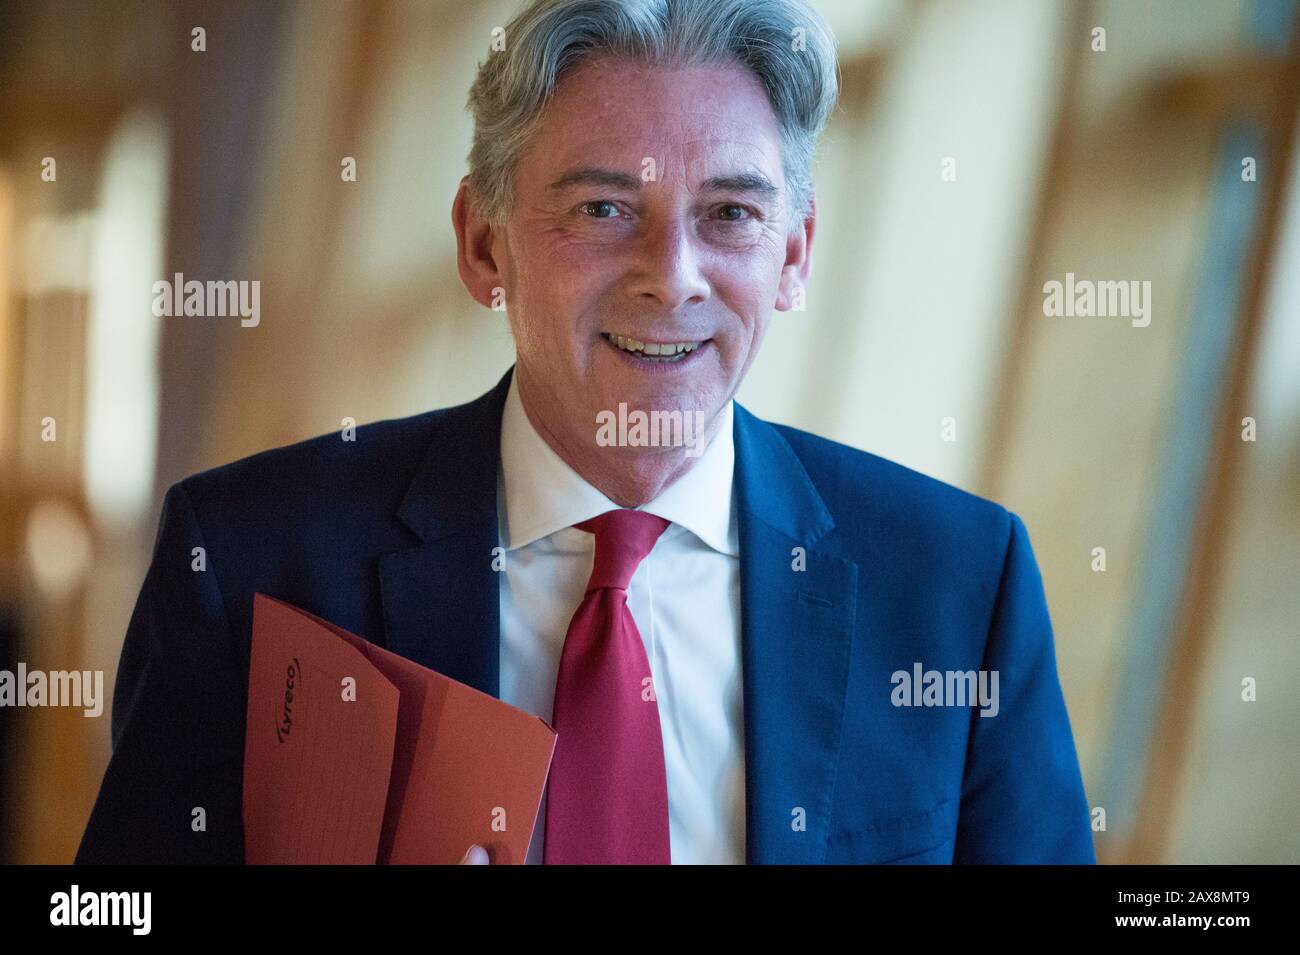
[{"xmin": 493, "ymin": 58, "xmax": 811, "ymax": 462}]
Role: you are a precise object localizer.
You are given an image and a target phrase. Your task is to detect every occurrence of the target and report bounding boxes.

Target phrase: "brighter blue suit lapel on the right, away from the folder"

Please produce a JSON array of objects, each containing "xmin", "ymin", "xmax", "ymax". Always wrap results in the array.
[{"xmin": 735, "ymin": 404, "xmax": 858, "ymax": 863}]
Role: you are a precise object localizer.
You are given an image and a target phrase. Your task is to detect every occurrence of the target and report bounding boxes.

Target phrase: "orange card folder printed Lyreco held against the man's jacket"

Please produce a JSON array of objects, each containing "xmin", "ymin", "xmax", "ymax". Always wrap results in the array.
[{"xmin": 243, "ymin": 594, "xmax": 555, "ymax": 864}]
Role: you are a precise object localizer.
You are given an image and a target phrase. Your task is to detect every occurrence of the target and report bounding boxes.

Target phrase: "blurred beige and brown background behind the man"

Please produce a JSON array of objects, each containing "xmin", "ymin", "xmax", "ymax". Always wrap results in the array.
[{"xmin": 0, "ymin": 0, "xmax": 1300, "ymax": 863}]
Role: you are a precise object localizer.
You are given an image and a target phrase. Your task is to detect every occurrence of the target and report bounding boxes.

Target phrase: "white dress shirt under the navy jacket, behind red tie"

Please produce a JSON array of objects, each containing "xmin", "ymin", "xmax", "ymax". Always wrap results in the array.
[{"xmin": 497, "ymin": 374, "xmax": 745, "ymax": 864}]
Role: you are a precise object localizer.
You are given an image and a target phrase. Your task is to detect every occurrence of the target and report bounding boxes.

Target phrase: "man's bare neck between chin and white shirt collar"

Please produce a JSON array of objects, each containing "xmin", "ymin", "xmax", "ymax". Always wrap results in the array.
[{"xmin": 516, "ymin": 368, "xmax": 723, "ymax": 508}]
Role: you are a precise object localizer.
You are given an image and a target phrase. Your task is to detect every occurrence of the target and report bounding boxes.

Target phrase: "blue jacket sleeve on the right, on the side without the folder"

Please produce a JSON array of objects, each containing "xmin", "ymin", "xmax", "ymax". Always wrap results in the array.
[{"xmin": 953, "ymin": 513, "xmax": 1096, "ymax": 864}]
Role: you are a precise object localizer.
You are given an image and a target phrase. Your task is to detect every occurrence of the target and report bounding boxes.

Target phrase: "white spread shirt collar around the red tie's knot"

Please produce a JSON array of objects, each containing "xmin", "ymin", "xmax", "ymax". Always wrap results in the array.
[{"xmin": 497, "ymin": 374, "xmax": 740, "ymax": 557}]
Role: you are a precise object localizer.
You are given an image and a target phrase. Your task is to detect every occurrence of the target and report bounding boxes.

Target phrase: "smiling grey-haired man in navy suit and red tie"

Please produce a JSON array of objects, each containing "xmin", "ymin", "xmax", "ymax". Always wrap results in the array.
[{"xmin": 78, "ymin": 0, "xmax": 1095, "ymax": 863}]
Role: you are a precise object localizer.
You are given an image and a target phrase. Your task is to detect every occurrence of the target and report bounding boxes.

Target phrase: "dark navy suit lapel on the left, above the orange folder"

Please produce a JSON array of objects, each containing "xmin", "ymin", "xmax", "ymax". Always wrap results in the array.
[{"xmin": 380, "ymin": 368, "xmax": 514, "ymax": 696}]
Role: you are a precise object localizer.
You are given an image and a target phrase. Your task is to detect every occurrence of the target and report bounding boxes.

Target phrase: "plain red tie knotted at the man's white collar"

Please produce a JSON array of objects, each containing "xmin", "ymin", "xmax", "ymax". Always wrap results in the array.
[{"xmin": 542, "ymin": 509, "xmax": 670, "ymax": 865}]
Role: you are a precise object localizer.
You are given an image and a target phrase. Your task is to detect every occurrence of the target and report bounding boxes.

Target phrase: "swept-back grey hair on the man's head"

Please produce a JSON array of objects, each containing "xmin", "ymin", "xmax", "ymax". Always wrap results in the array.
[{"xmin": 468, "ymin": 0, "xmax": 839, "ymax": 227}]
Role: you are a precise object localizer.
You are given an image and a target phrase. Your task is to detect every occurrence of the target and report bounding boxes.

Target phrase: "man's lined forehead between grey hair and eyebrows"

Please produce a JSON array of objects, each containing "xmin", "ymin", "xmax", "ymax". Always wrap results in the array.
[{"xmin": 517, "ymin": 58, "xmax": 781, "ymax": 186}]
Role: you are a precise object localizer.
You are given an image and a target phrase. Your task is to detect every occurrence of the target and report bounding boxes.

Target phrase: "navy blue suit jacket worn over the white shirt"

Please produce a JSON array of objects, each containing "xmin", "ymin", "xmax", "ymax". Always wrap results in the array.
[{"xmin": 77, "ymin": 372, "xmax": 1096, "ymax": 863}]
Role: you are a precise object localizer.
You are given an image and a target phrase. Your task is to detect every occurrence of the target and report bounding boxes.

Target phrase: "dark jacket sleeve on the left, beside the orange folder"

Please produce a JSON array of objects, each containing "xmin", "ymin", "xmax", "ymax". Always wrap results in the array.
[{"xmin": 77, "ymin": 482, "xmax": 247, "ymax": 863}]
